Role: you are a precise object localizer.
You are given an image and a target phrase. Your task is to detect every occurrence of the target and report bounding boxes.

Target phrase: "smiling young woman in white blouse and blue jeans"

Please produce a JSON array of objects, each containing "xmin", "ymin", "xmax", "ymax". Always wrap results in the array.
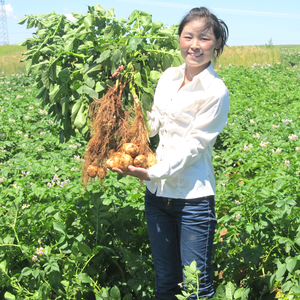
[{"xmin": 114, "ymin": 7, "xmax": 229, "ymax": 300}]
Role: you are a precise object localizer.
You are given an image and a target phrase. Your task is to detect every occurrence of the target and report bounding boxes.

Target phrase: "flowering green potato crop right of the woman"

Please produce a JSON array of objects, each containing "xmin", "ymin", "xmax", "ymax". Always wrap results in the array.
[{"xmin": 214, "ymin": 54, "xmax": 300, "ymax": 299}]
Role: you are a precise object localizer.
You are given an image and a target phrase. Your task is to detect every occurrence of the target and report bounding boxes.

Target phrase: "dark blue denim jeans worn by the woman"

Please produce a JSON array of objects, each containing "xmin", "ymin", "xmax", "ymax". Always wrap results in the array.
[{"xmin": 145, "ymin": 189, "xmax": 216, "ymax": 300}]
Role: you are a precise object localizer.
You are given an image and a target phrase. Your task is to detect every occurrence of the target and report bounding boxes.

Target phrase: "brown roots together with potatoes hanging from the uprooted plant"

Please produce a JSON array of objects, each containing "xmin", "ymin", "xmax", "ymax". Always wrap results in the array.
[{"xmin": 82, "ymin": 73, "xmax": 156, "ymax": 184}]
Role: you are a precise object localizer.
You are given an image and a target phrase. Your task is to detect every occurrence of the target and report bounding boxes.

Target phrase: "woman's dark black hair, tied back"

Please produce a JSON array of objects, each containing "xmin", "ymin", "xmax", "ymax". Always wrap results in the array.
[{"xmin": 178, "ymin": 7, "xmax": 229, "ymax": 58}]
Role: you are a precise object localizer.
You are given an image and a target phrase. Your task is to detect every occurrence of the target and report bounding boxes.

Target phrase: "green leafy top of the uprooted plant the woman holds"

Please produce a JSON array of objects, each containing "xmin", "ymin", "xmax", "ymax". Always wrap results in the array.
[{"xmin": 19, "ymin": 5, "xmax": 182, "ymax": 142}]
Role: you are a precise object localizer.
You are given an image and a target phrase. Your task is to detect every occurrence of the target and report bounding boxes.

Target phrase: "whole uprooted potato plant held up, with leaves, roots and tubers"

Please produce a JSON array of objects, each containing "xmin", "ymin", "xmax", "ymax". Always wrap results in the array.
[{"xmin": 19, "ymin": 5, "xmax": 182, "ymax": 184}]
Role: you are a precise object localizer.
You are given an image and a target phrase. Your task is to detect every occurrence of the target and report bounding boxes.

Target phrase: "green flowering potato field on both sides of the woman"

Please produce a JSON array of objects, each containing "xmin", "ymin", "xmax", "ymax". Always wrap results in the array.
[{"xmin": 0, "ymin": 49, "xmax": 300, "ymax": 300}]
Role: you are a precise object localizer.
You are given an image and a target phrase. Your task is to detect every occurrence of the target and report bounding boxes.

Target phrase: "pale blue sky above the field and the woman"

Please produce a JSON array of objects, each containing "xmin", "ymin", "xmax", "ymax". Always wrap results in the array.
[{"xmin": 5, "ymin": 0, "xmax": 300, "ymax": 46}]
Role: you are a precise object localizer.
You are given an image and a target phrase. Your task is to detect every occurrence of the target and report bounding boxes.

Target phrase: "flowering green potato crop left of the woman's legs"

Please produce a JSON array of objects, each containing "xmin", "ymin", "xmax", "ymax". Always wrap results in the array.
[{"xmin": 0, "ymin": 75, "xmax": 154, "ymax": 300}]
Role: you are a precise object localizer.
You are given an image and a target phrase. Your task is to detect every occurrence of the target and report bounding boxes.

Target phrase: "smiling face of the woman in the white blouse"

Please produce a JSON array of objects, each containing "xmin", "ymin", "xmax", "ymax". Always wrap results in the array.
[{"xmin": 179, "ymin": 19, "xmax": 222, "ymax": 76}]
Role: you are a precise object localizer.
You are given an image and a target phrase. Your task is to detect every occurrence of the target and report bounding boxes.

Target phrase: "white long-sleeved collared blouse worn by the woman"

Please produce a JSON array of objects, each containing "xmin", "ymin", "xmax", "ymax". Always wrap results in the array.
[{"xmin": 145, "ymin": 63, "xmax": 229, "ymax": 199}]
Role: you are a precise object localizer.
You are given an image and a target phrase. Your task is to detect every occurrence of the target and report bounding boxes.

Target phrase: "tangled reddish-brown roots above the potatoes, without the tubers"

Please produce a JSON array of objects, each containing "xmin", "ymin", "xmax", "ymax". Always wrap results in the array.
[{"xmin": 82, "ymin": 83, "xmax": 152, "ymax": 186}]
